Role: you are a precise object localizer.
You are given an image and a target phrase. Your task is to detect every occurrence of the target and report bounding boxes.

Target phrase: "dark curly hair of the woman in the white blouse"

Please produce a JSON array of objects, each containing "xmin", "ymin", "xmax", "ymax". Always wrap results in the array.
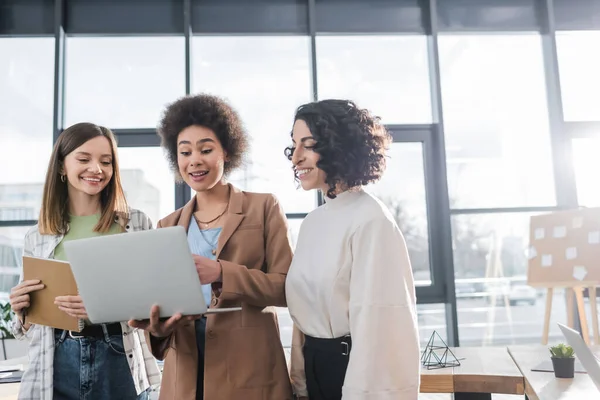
[{"xmin": 285, "ymin": 99, "xmax": 391, "ymax": 199}]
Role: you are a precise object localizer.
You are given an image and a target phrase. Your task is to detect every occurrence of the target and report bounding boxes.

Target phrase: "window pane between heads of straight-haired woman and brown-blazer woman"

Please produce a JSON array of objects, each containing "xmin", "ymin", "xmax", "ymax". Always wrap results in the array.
[{"xmin": 119, "ymin": 147, "xmax": 175, "ymax": 226}]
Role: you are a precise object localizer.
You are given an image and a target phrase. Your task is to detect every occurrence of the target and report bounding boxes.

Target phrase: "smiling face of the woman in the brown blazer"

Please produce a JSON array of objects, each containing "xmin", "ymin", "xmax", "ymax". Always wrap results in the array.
[{"xmin": 177, "ymin": 125, "xmax": 227, "ymax": 192}]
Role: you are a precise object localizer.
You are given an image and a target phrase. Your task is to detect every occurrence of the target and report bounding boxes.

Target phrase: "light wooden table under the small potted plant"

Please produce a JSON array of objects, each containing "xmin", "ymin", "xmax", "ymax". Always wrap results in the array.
[{"xmin": 508, "ymin": 345, "xmax": 600, "ymax": 400}]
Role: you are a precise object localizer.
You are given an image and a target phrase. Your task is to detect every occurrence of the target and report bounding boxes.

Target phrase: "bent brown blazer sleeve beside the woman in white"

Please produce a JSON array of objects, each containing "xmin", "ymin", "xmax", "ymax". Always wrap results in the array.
[{"xmin": 219, "ymin": 195, "xmax": 292, "ymax": 307}]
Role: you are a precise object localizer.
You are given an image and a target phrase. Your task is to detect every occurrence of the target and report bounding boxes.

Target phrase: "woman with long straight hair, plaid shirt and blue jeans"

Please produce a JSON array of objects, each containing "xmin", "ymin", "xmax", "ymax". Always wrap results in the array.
[{"xmin": 10, "ymin": 123, "xmax": 160, "ymax": 400}]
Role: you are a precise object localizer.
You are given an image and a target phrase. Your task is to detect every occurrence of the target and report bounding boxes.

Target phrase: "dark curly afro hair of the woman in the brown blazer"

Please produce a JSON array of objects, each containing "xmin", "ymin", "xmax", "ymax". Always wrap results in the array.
[{"xmin": 158, "ymin": 94, "xmax": 250, "ymax": 180}]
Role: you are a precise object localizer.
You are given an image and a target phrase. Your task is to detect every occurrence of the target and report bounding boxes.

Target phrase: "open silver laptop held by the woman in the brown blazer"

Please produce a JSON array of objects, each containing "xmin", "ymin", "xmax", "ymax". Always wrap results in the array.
[{"xmin": 64, "ymin": 226, "xmax": 241, "ymax": 324}]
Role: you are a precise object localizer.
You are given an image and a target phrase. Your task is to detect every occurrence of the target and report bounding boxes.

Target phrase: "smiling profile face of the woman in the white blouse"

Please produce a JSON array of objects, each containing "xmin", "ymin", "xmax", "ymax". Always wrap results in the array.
[{"xmin": 292, "ymin": 119, "xmax": 327, "ymax": 191}]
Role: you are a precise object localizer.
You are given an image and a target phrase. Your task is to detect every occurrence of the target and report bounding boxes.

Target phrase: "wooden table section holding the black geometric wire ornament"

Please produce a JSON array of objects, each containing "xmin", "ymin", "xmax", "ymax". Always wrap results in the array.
[{"xmin": 420, "ymin": 347, "xmax": 525, "ymax": 400}]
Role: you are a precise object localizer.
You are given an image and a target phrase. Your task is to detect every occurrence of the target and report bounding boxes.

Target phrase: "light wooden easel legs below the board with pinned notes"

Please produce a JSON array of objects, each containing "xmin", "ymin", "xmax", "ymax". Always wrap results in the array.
[{"xmin": 540, "ymin": 282, "xmax": 600, "ymax": 345}]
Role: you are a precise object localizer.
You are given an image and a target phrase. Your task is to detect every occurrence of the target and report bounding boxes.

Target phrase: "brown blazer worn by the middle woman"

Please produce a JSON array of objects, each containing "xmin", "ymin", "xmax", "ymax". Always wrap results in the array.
[{"xmin": 148, "ymin": 185, "xmax": 292, "ymax": 400}]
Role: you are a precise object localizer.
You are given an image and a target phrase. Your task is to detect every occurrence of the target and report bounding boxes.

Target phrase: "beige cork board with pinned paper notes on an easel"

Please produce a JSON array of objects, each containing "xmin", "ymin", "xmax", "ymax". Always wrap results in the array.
[{"xmin": 527, "ymin": 208, "xmax": 600, "ymax": 287}]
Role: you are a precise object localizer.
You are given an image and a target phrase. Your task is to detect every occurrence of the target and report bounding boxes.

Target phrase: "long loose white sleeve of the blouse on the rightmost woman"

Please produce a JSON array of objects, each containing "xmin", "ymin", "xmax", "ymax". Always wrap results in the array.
[{"xmin": 343, "ymin": 215, "xmax": 420, "ymax": 400}]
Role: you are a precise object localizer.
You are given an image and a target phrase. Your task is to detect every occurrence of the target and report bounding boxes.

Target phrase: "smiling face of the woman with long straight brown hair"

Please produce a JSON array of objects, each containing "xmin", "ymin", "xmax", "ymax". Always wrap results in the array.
[{"xmin": 61, "ymin": 136, "xmax": 114, "ymax": 196}]
